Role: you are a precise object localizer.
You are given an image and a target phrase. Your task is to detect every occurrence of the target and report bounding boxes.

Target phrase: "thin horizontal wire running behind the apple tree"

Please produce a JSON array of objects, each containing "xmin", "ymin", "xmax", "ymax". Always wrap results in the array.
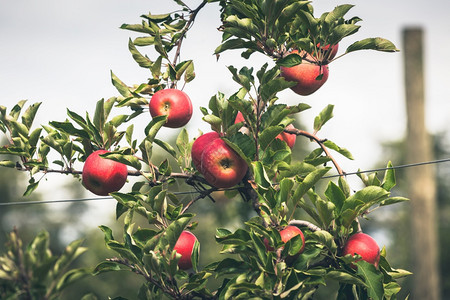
[{"xmin": 0, "ymin": 158, "xmax": 450, "ymax": 206}]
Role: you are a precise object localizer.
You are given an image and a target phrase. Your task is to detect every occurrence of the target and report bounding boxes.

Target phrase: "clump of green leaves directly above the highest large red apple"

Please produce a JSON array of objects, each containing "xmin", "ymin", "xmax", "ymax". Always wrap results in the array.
[{"xmin": 215, "ymin": 0, "xmax": 398, "ymax": 61}]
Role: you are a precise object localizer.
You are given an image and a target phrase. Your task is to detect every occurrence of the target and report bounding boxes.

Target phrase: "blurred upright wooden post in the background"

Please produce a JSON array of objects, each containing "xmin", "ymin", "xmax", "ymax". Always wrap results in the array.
[{"xmin": 403, "ymin": 28, "xmax": 440, "ymax": 300}]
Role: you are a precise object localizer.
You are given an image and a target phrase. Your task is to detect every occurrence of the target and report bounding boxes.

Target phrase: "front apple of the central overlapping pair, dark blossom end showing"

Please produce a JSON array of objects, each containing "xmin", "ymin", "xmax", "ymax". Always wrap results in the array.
[{"xmin": 200, "ymin": 139, "xmax": 248, "ymax": 188}]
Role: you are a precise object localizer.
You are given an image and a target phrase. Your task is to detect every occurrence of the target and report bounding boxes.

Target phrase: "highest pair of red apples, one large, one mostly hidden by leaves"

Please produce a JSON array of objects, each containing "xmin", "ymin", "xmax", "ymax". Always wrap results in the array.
[{"xmin": 280, "ymin": 44, "xmax": 339, "ymax": 96}]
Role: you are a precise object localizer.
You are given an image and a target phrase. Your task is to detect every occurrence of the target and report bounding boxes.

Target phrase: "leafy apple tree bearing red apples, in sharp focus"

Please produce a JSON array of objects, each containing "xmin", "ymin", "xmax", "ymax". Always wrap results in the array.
[{"xmin": 0, "ymin": 0, "xmax": 409, "ymax": 299}]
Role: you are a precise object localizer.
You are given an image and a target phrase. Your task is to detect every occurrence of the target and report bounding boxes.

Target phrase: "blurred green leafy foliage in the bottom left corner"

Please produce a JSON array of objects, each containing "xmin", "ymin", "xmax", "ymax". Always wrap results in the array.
[{"xmin": 0, "ymin": 230, "xmax": 90, "ymax": 299}]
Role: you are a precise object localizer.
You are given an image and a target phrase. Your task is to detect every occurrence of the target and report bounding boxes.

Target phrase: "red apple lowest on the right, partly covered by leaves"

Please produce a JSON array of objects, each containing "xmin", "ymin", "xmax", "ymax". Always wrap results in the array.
[{"xmin": 342, "ymin": 232, "xmax": 380, "ymax": 267}]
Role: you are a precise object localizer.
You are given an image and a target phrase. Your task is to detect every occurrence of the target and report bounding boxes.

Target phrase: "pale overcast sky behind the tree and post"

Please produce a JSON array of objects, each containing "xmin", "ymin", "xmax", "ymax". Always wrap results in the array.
[{"xmin": 0, "ymin": 0, "xmax": 450, "ymax": 202}]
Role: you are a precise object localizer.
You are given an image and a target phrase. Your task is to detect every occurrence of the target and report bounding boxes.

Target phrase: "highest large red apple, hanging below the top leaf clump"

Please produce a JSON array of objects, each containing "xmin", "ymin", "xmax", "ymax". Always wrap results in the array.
[{"xmin": 280, "ymin": 51, "xmax": 328, "ymax": 96}]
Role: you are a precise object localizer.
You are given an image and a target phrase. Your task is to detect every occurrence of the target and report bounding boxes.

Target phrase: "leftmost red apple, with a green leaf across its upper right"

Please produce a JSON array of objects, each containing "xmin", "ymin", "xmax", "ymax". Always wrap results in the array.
[{"xmin": 82, "ymin": 150, "xmax": 128, "ymax": 196}]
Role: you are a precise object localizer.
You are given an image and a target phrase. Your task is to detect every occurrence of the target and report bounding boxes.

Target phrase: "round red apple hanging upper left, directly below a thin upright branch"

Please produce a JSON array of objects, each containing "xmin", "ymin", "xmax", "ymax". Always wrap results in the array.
[{"xmin": 149, "ymin": 89, "xmax": 193, "ymax": 128}]
